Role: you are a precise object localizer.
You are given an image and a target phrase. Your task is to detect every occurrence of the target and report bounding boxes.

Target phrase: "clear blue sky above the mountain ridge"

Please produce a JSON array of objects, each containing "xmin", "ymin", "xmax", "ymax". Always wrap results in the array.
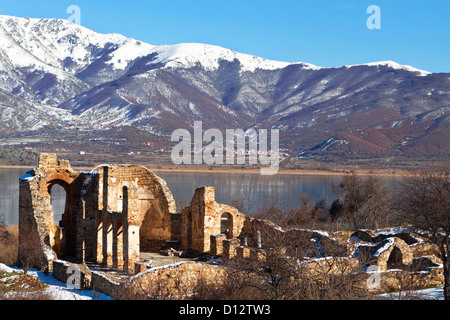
[{"xmin": 0, "ymin": 0, "xmax": 450, "ymax": 72}]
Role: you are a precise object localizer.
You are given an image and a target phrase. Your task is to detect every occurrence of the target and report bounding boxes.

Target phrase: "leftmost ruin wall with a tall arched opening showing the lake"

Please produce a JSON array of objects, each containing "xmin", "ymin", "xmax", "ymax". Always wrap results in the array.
[{"xmin": 19, "ymin": 153, "xmax": 80, "ymax": 267}]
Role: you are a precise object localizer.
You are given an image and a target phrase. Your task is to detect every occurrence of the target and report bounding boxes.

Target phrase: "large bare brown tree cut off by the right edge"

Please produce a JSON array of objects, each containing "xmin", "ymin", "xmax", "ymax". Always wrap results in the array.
[{"xmin": 396, "ymin": 165, "xmax": 450, "ymax": 300}]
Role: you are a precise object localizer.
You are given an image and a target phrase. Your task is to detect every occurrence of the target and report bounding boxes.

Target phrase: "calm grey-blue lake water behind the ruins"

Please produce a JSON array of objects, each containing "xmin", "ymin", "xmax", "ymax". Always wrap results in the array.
[{"xmin": 0, "ymin": 168, "xmax": 348, "ymax": 225}]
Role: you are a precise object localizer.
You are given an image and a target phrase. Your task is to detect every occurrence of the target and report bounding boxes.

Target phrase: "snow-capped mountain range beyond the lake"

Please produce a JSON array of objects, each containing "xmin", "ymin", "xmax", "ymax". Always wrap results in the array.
[{"xmin": 0, "ymin": 16, "xmax": 450, "ymax": 158}]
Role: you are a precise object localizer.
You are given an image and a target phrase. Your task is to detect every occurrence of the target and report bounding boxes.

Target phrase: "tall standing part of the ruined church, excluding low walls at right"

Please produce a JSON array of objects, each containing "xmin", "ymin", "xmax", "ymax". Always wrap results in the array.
[{"xmin": 19, "ymin": 153, "xmax": 256, "ymax": 273}]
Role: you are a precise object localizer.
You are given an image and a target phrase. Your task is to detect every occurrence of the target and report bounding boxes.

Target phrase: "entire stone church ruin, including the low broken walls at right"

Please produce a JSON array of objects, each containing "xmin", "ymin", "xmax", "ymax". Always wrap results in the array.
[{"xmin": 19, "ymin": 154, "xmax": 442, "ymax": 296}]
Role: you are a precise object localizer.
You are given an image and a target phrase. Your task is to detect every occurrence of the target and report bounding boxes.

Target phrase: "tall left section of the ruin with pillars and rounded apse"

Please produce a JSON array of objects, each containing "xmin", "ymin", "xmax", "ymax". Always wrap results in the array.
[{"xmin": 19, "ymin": 153, "xmax": 180, "ymax": 271}]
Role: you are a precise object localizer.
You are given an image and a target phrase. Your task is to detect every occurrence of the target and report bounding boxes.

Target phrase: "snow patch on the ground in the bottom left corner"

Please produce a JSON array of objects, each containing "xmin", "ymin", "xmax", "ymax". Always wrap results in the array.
[{"xmin": 0, "ymin": 263, "xmax": 113, "ymax": 300}]
